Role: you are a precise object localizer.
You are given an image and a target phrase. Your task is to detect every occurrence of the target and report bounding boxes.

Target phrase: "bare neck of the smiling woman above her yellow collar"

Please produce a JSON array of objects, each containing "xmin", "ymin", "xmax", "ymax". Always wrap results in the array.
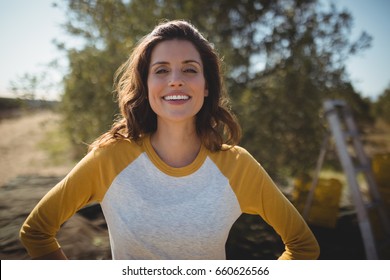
[{"xmin": 150, "ymin": 122, "xmax": 201, "ymax": 168}]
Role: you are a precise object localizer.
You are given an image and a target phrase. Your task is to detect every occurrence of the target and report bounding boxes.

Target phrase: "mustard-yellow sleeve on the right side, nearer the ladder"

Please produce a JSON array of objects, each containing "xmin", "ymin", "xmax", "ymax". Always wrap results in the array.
[{"xmin": 210, "ymin": 147, "xmax": 319, "ymax": 259}]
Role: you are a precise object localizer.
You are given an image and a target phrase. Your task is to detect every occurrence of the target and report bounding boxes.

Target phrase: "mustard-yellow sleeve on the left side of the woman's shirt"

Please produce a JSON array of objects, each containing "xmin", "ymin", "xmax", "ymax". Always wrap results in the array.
[{"xmin": 19, "ymin": 141, "xmax": 140, "ymax": 258}]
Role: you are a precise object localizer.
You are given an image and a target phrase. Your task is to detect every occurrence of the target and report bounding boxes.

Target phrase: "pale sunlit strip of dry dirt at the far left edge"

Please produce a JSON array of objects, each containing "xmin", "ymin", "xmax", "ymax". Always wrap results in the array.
[{"xmin": 0, "ymin": 111, "xmax": 71, "ymax": 186}]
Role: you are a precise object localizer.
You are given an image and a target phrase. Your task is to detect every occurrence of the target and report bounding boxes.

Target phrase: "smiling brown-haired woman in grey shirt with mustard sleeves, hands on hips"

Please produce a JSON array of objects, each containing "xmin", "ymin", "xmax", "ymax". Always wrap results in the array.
[{"xmin": 20, "ymin": 21, "xmax": 319, "ymax": 259}]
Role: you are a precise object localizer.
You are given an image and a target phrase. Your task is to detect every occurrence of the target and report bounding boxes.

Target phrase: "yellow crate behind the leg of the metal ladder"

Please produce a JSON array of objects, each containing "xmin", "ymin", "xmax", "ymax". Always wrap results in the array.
[{"xmin": 292, "ymin": 178, "xmax": 343, "ymax": 228}]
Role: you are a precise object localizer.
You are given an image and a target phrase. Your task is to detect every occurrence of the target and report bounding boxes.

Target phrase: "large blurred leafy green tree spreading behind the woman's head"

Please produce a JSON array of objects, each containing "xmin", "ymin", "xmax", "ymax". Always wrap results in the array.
[{"xmin": 61, "ymin": 0, "xmax": 371, "ymax": 175}]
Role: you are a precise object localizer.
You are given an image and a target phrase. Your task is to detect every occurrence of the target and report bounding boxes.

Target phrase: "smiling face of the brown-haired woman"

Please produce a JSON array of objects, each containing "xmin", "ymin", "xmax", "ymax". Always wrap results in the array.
[{"xmin": 147, "ymin": 39, "xmax": 208, "ymax": 126}]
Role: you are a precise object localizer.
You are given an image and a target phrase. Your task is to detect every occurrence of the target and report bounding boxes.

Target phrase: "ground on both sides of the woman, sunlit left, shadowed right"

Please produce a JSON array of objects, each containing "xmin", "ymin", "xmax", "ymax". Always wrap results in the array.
[{"xmin": 0, "ymin": 111, "xmax": 386, "ymax": 260}]
